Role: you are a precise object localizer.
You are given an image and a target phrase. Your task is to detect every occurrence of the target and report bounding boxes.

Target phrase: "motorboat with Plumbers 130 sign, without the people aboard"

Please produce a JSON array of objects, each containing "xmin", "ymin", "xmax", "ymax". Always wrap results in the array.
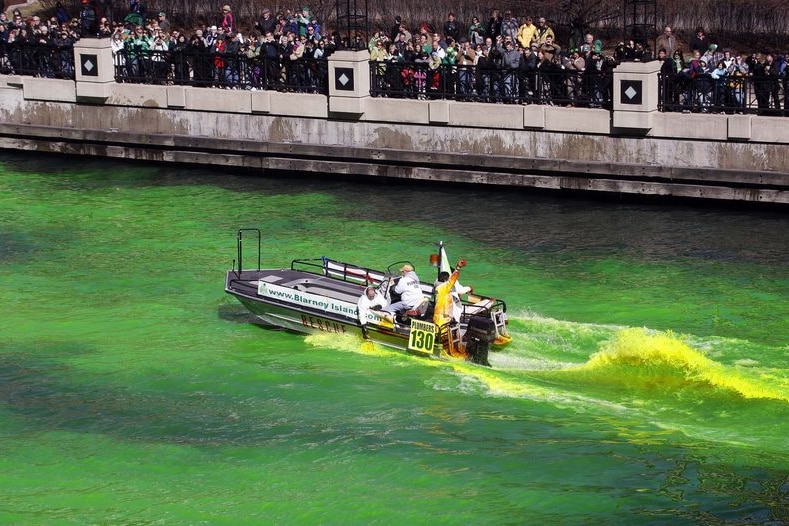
[{"xmin": 225, "ymin": 228, "xmax": 512, "ymax": 366}]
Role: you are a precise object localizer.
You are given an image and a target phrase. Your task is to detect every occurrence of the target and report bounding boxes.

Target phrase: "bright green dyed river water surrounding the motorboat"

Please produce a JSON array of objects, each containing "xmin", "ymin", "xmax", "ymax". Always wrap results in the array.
[{"xmin": 0, "ymin": 154, "xmax": 789, "ymax": 525}]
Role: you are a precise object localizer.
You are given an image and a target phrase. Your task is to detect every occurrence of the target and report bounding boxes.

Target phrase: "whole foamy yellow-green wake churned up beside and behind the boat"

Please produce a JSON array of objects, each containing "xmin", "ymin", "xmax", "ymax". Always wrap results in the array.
[{"xmin": 306, "ymin": 312, "xmax": 789, "ymax": 407}]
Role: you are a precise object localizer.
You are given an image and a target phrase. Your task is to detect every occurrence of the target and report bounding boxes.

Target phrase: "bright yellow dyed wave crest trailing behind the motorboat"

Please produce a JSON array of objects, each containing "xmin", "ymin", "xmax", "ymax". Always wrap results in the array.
[{"xmin": 580, "ymin": 328, "xmax": 789, "ymax": 401}]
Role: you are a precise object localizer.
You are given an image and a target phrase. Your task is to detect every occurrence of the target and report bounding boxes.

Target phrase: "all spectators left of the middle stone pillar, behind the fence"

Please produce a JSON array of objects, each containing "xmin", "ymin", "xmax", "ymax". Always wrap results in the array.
[{"xmin": 0, "ymin": 0, "xmax": 350, "ymax": 91}]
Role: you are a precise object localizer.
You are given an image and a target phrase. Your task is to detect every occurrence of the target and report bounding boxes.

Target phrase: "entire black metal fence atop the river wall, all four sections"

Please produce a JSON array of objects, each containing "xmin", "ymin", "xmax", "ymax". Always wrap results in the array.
[{"xmin": 6, "ymin": 42, "xmax": 789, "ymax": 115}]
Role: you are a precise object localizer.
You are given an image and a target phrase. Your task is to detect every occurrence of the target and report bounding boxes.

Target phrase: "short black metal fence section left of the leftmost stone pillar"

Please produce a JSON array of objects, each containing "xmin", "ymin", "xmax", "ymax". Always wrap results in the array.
[{"xmin": 0, "ymin": 41, "xmax": 74, "ymax": 80}]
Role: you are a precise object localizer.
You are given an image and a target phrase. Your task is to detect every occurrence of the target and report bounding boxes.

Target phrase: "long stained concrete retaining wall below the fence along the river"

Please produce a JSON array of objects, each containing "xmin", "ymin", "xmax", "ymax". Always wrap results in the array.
[{"xmin": 0, "ymin": 71, "xmax": 789, "ymax": 207}]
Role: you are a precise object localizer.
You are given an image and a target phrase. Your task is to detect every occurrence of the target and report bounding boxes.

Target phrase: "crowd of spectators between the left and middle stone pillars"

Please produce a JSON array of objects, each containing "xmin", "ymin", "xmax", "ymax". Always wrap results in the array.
[{"xmin": 106, "ymin": 4, "xmax": 341, "ymax": 91}]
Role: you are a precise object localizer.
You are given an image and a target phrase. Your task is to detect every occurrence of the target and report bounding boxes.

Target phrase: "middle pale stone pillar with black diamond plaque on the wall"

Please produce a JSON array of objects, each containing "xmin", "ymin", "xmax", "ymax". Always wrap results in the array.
[{"xmin": 328, "ymin": 50, "xmax": 370, "ymax": 118}]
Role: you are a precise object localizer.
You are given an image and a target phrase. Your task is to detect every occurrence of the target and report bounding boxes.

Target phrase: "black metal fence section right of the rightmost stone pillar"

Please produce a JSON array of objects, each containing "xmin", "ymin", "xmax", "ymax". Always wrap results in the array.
[{"xmin": 658, "ymin": 74, "xmax": 789, "ymax": 115}]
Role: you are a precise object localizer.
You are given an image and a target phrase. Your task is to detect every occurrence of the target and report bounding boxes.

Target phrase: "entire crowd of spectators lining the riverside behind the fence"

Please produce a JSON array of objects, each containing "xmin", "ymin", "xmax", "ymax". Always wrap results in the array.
[{"xmin": 0, "ymin": 0, "xmax": 789, "ymax": 113}]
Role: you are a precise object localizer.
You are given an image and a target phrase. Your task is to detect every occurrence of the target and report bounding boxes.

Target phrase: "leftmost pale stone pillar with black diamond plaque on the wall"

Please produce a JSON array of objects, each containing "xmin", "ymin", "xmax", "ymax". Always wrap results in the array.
[{"xmin": 74, "ymin": 38, "xmax": 115, "ymax": 104}]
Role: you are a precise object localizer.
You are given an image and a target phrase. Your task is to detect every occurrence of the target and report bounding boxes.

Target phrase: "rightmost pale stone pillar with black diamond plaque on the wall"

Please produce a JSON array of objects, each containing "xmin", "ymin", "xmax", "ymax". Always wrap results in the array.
[{"xmin": 614, "ymin": 60, "xmax": 662, "ymax": 135}]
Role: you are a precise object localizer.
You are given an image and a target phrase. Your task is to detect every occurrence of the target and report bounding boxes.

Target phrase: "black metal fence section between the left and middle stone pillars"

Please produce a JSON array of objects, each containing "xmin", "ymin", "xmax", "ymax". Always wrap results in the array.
[{"xmin": 115, "ymin": 49, "xmax": 329, "ymax": 94}]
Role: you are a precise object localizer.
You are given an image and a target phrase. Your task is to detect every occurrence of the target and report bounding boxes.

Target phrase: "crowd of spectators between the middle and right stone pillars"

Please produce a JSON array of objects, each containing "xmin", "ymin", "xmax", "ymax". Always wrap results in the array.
[{"xmin": 368, "ymin": 9, "xmax": 616, "ymax": 107}]
